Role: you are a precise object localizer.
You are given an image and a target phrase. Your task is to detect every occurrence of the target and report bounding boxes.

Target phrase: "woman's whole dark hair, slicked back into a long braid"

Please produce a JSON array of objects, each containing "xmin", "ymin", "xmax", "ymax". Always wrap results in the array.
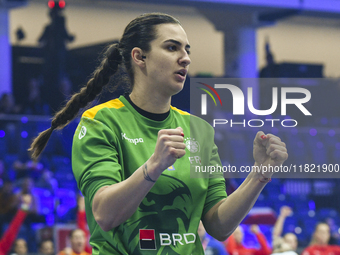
[{"xmin": 28, "ymin": 13, "xmax": 180, "ymax": 159}]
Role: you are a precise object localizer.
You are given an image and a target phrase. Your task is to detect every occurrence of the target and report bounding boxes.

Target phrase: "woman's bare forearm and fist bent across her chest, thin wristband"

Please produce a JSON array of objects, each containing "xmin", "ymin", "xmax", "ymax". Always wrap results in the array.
[{"xmin": 92, "ymin": 128, "xmax": 185, "ymax": 231}]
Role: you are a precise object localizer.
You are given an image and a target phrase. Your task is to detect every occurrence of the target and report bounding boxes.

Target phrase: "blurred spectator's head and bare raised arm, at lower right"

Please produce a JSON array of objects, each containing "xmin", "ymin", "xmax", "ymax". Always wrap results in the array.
[{"xmin": 273, "ymin": 206, "xmax": 298, "ymax": 251}]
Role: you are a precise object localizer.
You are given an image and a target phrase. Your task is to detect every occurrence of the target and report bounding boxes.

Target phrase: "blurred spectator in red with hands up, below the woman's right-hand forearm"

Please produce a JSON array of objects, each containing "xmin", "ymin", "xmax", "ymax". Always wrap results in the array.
[{"xmin": 224, "ymin": 225, "xmax": 271, "ymax": 255}]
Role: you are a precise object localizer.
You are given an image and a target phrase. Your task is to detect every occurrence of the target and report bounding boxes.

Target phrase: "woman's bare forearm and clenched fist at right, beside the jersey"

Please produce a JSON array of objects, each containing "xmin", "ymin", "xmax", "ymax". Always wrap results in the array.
[{"xmin": 203, "ymin": 132, "xmax": 288, "ymax": 241}]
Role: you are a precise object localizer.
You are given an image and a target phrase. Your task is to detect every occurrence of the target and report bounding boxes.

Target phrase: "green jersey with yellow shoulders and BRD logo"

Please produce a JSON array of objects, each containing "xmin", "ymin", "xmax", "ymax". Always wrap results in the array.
[{"xmin": 72, "ymin": 96, "xmax": 227, "ymax": 255}]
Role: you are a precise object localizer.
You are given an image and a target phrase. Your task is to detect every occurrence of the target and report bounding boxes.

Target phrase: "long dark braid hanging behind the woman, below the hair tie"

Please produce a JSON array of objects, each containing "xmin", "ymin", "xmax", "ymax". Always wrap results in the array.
[{"xmin": 28, "ymin": 43, "xmax": 122, "ymax": 159}]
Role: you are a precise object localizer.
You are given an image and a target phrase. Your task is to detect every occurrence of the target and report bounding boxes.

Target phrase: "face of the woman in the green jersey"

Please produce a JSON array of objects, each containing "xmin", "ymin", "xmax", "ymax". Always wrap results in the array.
[{"xmin": 144, "ymin": 24, "xmax": 191, "ymax": 96}]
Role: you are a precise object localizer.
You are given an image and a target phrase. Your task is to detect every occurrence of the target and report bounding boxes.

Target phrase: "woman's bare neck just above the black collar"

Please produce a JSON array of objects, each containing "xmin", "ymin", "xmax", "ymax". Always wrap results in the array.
[{"xmin": 130, "ymin": 86, "xmax": 171, "ymax": 114}]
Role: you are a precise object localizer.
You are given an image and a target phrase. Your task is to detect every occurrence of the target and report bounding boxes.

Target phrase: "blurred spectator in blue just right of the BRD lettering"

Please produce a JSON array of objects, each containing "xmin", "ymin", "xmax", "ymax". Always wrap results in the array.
[{"xmin": 197, "ymin": 221, "xmax": 227, "ymax": 255}]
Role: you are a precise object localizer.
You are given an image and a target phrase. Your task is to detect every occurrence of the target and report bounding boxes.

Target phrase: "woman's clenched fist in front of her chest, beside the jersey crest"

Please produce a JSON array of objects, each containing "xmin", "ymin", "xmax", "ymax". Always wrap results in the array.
[{"xmin": 149, "ymin": 127, "xmax": 185, "ymax": 174}]
